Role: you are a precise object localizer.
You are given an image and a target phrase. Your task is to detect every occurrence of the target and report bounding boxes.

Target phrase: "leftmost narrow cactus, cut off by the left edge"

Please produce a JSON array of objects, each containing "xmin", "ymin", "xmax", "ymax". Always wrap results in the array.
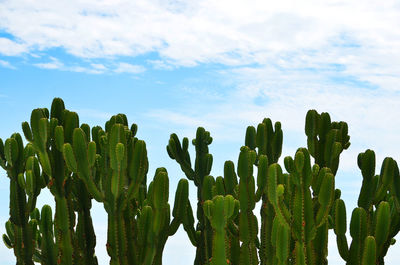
[{"xmin": 0, "ymin": 133, "xmax": 45, "ymax": 265}]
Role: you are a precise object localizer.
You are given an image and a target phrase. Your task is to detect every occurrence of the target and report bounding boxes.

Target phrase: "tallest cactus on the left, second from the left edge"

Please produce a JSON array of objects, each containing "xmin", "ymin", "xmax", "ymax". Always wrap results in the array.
[{"xmin": 22, "ymin": 98, "xmax": 97, "ymax": 265}]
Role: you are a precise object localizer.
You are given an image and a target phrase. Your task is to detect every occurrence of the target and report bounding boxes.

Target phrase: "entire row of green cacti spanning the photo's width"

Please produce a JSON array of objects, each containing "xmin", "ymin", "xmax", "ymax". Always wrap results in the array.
[{"xmin": 0, "ymin": 98, "xmax": 400, "ymax": 265}]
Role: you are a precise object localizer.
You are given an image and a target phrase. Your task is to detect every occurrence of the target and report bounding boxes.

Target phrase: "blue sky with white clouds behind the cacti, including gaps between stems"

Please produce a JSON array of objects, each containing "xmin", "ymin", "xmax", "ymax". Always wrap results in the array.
[{"xmin": 0, "ymin": 0, "xmax": 400, "ymax": 265}]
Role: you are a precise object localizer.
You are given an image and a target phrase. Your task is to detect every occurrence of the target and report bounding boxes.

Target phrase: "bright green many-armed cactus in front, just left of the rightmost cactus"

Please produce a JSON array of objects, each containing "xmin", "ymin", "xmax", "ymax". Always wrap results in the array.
[{"xmin": 282, "ymin": 148, "xmax": 334, "ymax": 264}]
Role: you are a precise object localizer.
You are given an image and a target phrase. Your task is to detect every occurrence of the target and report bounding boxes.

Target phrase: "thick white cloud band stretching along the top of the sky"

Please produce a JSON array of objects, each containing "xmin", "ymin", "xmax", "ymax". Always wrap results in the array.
[{"xmin": 0, "ymin": 0, "xmax": 400, "ymax": 69}]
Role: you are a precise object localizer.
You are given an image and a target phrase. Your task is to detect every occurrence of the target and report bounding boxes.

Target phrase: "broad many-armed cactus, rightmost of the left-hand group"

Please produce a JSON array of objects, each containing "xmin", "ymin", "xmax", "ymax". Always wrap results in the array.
[{"xmin": 63, "ymin": 114, "xmax": 188, "ymax": 265}]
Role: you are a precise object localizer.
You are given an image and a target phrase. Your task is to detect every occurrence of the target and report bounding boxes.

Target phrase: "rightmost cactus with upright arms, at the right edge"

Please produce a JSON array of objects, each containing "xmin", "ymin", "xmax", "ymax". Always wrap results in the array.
[{"xmin": 335, "ymin": 149, "xmax": 400, "ymax": 265}]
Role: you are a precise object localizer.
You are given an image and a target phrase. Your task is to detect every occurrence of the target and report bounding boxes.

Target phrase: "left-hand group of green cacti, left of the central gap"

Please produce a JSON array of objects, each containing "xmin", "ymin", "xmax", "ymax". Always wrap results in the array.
[{"xmin": 0, "ymin": 98, "xmax": 188, "ymax": 265}]
